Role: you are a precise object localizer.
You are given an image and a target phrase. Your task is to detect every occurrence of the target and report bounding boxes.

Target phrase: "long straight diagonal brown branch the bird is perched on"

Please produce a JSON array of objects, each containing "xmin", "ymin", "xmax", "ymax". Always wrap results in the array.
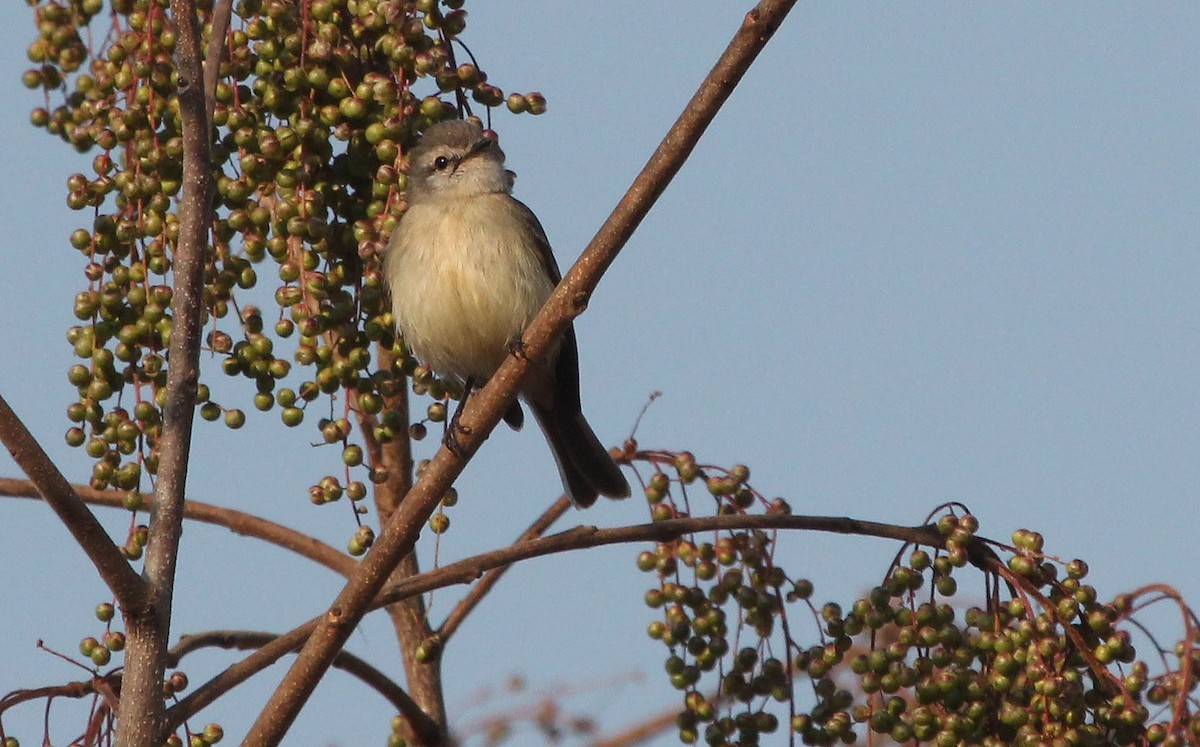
[{"xmin": 246, "ymin": 0, "xmax": 794, "ymax": 747}]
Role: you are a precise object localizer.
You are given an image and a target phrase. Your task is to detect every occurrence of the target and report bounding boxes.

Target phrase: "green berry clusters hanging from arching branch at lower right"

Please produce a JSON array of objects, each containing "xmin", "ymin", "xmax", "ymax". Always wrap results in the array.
[{"xmin": 636, "ymin": 452, "xmax": 1200, "ymax": 747}]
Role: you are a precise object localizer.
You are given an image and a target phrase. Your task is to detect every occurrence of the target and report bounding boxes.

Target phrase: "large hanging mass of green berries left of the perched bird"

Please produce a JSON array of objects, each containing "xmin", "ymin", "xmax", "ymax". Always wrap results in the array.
[{"xmin": 23, "ymin": 0, "xmax": 545, "ymax": 552}]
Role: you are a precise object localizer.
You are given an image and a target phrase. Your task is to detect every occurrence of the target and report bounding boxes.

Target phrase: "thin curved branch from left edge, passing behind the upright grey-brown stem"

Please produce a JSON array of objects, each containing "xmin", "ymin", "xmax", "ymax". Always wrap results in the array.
[{"xmin": 0, "ymin": 477, "xmax": 358, "ymax": 576}]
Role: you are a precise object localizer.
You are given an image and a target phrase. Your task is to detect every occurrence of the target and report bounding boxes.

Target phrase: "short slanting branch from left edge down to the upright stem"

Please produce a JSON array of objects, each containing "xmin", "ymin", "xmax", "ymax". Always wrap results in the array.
[{"xmin": 0, "ymin": 396, "xmax": 146, "ymax": 606}]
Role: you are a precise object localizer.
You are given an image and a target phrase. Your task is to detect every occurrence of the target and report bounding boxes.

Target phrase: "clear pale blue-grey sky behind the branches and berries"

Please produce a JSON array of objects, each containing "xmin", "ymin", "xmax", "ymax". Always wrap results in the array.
[{"xmin": 0, "ymin": 0, "xmax": 1200, "ymax": 746}]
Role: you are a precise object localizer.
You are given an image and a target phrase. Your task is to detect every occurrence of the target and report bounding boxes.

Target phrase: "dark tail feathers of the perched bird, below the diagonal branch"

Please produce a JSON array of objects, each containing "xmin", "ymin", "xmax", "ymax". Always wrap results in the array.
[{"xmin": 530, "ymin": 406, "xmax": 629, "ymax": 508}]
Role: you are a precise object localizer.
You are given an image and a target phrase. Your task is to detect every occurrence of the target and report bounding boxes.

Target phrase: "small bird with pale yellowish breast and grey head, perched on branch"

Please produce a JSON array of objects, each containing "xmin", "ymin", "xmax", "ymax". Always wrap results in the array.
[{"xmin": 384, "ymin": 120, "xmax": 629, "ymax": 508}]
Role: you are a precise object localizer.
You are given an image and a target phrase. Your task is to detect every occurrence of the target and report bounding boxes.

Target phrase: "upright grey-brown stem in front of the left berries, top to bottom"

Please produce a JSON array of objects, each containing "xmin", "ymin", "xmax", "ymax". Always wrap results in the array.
[{"xmin": 116, "ymin": 0, "xmax": 214, "ymax": 747}]
